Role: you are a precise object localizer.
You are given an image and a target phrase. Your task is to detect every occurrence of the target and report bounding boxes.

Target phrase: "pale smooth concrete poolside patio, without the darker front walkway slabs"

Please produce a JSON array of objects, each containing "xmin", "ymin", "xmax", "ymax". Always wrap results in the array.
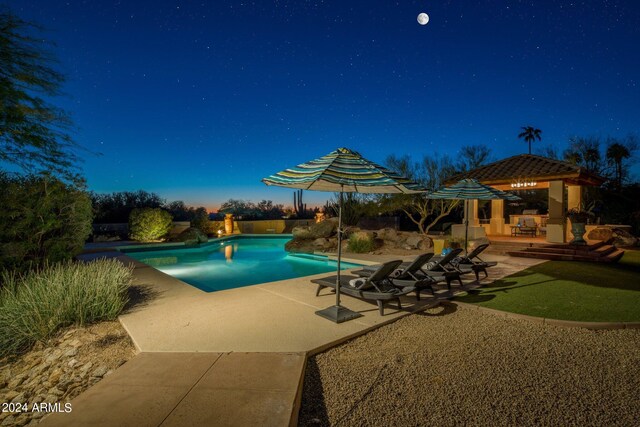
[{"xmin": 71, "ymin": 252, "xmax": 541, "ymax": 354}]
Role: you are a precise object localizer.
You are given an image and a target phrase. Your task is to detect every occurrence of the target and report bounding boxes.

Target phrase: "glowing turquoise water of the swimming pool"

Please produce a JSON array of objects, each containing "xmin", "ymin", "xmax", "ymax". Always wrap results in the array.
[{"xmin": 124, "ymin": 236, "xmax": 357, "ymax": 292}]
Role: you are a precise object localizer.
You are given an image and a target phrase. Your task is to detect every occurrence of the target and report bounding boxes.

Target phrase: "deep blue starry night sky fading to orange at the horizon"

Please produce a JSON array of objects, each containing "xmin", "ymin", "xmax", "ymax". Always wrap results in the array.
[{"xmin": 4, "ymin": 0, "xmax": 640, "ymax": 209}]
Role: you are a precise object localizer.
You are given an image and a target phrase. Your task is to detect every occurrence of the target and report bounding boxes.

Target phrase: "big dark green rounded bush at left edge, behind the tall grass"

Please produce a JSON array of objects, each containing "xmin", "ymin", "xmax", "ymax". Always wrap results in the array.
[{"xmin": 0, "ymin": 173, "xmax": 93, "ymax": 270}]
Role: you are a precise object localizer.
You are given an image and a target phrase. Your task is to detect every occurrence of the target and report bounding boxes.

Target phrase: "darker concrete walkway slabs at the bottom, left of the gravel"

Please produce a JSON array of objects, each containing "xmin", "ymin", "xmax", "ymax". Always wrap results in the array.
[{"xmin": 41, "ymin": 353, "xmax": 306, "ymax": 427}]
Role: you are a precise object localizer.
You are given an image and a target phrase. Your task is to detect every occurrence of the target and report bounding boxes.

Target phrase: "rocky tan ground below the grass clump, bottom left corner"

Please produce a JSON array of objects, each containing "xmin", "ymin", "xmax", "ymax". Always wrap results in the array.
[{"xmin": 0, "ymin": 322, "xmax": 135, "ymax": 426}]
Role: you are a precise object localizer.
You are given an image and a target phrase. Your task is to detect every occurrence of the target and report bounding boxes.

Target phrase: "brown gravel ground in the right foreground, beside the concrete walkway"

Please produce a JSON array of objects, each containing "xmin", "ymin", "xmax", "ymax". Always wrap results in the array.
[{"xmin": 299, "ymin": 304, "xmax": 640, "ymax": 426}]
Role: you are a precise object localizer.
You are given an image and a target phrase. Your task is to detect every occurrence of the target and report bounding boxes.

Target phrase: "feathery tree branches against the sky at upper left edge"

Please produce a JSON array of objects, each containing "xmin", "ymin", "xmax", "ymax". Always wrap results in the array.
[{"xmin": 0, "ymin": 10, "xmax": 78, "ymax": 178}]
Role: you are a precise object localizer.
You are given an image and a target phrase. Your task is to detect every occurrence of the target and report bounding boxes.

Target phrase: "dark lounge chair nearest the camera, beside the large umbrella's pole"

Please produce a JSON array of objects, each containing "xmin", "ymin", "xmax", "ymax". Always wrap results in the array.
[{"xmin": 311, "ymin": 260, "xmax": 416, "ymax": 316}]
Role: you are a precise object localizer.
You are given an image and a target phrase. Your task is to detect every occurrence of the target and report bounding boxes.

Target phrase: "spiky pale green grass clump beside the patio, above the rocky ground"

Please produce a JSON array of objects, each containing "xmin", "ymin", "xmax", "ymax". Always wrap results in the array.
[{"xmin": 0, "ymin": 259, "xmax": 132, "ymax": 357}]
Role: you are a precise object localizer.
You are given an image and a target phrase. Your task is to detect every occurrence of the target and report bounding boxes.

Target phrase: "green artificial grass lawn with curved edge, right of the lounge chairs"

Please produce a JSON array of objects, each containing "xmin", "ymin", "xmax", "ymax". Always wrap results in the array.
[{"xmin": 456, "ymin": 250, "xmax": 640, "ymax": 322}]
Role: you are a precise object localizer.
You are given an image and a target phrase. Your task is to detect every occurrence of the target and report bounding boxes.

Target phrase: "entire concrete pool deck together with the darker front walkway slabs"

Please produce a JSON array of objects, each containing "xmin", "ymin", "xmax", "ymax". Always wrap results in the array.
[{"xmin": 43, "ymin": 252, "xmax": 540, "ymax": 426}]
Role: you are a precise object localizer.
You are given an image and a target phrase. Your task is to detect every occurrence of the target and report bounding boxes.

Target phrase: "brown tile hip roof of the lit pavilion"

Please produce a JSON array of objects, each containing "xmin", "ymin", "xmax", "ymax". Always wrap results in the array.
[{"xmin": 447, "ymin": 154, "xmax": 604, "ymax": 185}]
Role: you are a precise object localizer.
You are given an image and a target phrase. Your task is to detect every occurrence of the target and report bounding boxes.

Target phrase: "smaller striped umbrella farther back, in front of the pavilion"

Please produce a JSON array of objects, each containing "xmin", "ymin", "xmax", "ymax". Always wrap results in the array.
[{"xmin": 427, "ymin": 179, "xmax": 520, "ymax": 254}]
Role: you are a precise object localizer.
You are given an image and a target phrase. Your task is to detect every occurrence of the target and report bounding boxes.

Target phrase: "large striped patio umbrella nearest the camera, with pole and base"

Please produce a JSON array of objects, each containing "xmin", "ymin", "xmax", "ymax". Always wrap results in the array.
[{"xmin": 262, "ymin": 148, "xmax": 427, "ymax": 323}]
